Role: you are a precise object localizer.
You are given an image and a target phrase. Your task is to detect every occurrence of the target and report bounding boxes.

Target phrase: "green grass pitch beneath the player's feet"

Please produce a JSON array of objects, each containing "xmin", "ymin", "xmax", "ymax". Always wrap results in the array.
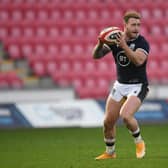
[{"xmin": 0, "ymin": 124, "xmax": 168, "ymax": 168}]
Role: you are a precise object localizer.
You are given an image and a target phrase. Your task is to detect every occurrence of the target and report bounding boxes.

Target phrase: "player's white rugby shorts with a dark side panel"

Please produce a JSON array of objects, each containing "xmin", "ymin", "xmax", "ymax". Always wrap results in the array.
[{"xmin": 110, "ymin": 81, "xmax": 149, "ymax": 102}]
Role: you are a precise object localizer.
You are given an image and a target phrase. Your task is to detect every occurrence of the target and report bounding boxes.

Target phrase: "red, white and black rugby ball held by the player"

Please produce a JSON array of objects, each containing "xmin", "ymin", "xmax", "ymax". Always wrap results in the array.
[{"xmin": 99, "ymin": 27, "xmax": 122, "ymax": 44}]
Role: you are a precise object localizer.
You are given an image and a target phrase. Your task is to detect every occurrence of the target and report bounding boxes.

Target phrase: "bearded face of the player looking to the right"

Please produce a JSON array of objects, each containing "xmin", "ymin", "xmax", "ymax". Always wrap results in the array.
[{"xmin": 125, "ymin": 18, "xmax": 141, "ymax": 39}]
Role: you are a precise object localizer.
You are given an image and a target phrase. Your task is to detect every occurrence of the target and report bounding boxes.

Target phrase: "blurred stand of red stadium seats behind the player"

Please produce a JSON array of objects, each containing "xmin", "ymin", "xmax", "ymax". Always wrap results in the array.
[{"xmin": 0, "ymin": 0, "xmax": 168, "ymax": 98}]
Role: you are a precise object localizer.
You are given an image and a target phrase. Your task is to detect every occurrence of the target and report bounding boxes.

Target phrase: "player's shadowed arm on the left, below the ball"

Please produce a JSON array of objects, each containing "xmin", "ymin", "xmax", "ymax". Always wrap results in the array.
[{"xmin": 93, "ymin": 40, "xmax": 111, "ymax": 59}]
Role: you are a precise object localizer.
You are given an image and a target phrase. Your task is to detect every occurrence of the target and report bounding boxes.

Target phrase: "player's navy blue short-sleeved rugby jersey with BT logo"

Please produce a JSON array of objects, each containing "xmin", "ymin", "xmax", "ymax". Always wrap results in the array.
[{"xmin": 109, "ymin": 35, "xmax": 150, "ymax": 84}]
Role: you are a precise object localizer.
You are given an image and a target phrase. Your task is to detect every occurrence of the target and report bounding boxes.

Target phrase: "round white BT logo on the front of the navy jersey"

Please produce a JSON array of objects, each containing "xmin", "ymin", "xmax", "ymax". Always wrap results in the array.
[{"xmin": 117, "ymin": 51, "xmax": 130, "ymax": 67}]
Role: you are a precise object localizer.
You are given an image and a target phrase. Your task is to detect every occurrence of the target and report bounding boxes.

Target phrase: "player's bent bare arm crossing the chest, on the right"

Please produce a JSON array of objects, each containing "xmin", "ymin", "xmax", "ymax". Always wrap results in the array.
[{"xmin": 117, "ymin": 35, "xmax": 148, "ymax": 66}]
